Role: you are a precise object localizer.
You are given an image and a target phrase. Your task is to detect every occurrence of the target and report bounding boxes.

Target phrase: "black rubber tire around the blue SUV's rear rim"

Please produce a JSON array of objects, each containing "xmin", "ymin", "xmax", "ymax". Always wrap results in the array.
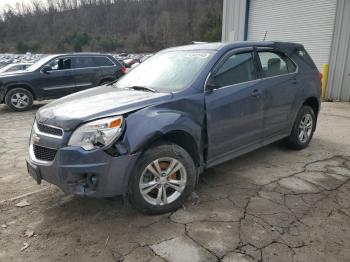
[{"xmin": 286, "ymin": 105, "xmax": 316, "ymax": 150}]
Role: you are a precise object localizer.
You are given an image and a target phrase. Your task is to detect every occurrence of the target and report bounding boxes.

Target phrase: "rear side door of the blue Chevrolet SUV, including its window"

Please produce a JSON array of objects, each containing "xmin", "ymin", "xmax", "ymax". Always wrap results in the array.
[{"xmin": 257, "ymin": 48, "xmax": 300, "ymax": 143}]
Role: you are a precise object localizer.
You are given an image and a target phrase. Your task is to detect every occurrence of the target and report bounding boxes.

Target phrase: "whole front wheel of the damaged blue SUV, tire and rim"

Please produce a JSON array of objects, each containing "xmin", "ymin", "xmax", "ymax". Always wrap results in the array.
[{"xmin": 128, "ymin": 143, "xmax": 196, "ymax": 215}]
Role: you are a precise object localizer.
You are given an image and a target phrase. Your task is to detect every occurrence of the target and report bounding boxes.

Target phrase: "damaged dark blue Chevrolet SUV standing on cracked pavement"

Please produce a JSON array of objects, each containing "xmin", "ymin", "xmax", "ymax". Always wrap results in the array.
[{"xmin": 27, "ymin": 42, "xmax": 321, "ymax": 214}]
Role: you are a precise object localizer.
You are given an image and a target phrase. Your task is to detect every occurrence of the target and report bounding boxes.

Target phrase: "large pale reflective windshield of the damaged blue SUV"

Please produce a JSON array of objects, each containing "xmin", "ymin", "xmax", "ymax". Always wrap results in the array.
[{"xmin": 115, "ymin": 51, "xmax": 213, "ymax": 92}]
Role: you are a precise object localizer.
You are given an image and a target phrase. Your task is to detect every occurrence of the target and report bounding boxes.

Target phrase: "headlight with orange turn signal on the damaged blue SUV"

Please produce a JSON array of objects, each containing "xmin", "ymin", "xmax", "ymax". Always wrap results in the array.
[{"xmin": 68, "ymin": 116, "xmax": 123, "ymax": 151}]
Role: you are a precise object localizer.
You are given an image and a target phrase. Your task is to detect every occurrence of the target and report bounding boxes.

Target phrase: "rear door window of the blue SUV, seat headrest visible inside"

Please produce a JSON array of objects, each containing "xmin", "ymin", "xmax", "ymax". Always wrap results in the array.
[{"xmin": 258, "ymin": 51, "xmax": 296, "ymax": 77}]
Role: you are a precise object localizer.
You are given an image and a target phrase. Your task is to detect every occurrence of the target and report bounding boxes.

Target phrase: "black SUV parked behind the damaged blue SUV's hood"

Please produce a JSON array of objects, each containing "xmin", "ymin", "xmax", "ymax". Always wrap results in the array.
[{"xmin": 0, "ymin": 53, "xmax": 125, "ymax": 111}]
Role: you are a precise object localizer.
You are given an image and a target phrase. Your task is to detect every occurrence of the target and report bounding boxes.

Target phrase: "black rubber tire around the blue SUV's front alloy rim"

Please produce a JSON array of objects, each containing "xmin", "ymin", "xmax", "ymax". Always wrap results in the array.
[{"xmin": 128, "ymin": 143, "xmax": 196, "ymax": 215}]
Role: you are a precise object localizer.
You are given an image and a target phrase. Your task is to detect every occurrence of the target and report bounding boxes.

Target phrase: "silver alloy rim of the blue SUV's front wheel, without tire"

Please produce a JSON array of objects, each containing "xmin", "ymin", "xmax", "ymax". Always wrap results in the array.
[{"xmin": 139, "ymin": 157, "xmax": 187, "ymax": 206}]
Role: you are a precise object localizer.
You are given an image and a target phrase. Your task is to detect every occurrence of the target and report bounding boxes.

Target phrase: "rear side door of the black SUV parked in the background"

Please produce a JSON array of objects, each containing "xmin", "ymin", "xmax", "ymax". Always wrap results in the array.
[{"xmin": 72, "ymin": 56, "xmax": 100, "ymax": 91}]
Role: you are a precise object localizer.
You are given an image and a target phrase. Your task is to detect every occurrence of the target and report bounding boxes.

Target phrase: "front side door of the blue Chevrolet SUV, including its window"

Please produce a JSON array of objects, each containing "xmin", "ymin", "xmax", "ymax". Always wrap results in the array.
[{"xmin": 205, "ymin": 48, "xmax": 264, "ymax": 166}]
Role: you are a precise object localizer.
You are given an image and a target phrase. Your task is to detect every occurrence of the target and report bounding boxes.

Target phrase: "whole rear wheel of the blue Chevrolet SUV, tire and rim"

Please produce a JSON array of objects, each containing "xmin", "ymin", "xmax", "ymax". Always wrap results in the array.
[{"xmin": 286, "ymin": 105, "xmax": 316, "ymax": 150}]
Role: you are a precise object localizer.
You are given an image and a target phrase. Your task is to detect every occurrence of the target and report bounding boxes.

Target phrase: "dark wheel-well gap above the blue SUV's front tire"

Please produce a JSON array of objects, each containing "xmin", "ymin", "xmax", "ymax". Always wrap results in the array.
[{"xmin": 144, "ymin": 131, "xmax": 200, "ymax": 166}]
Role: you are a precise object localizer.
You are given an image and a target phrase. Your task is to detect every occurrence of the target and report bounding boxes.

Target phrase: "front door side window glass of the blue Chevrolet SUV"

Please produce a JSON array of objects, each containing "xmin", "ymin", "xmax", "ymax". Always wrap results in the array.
[{"xmin": 214, "ymin": 53, "xmax": 255, "ymax": 86}]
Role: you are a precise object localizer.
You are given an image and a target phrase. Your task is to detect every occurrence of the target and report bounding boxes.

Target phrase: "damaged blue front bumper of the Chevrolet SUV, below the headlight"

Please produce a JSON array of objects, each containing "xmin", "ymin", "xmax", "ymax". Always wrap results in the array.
[{"xmin": 26, "ymin": 145, "xmax": 139, "ymax": 198}]
